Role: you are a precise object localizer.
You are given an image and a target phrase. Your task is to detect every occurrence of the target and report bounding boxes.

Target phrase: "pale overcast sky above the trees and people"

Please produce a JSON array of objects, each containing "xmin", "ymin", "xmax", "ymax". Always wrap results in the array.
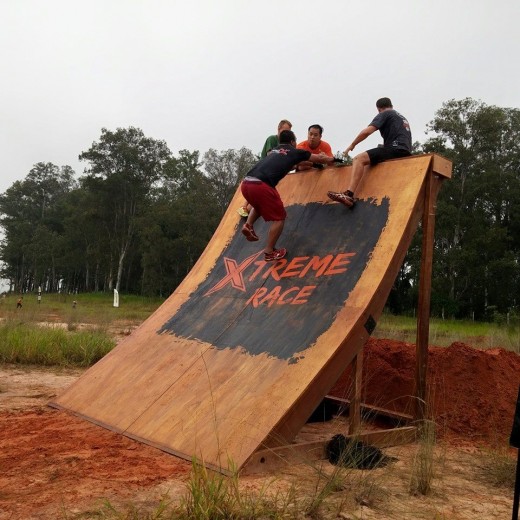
[{"xmin": 0, "ymin": 0, "xmax": 520, "ymax": 192}]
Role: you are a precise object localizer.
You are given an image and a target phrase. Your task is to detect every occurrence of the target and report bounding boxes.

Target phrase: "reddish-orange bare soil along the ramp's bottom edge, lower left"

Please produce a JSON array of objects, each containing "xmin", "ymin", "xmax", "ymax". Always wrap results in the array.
[{"xmin": 0, "ymin": 408, "xmax": 191, "ymax": 520}]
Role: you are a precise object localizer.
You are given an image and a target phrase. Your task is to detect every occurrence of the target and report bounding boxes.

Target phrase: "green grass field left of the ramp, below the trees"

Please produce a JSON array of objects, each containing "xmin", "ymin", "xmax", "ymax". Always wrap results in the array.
[{"xmin": 0, "ymin": 293, "xmax": 160, "ymax": 367}]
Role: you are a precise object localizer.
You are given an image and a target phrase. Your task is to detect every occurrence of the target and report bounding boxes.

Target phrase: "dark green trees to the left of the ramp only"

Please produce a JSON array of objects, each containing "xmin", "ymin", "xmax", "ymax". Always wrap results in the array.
[{"xmin": 0, "ymin": 127, "xmax": 256, "ymax": 296}]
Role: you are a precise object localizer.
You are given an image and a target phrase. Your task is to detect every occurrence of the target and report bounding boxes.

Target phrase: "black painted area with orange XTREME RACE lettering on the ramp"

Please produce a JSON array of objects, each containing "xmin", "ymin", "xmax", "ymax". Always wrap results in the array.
[{"xmin": 158, "ymin": 199, "xmax": 389, "ymax": 362}]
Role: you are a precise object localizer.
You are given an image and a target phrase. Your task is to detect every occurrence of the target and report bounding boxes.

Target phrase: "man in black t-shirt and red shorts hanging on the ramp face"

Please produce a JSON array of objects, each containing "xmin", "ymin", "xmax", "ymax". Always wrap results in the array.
[{"xmin": 240, "ymin": 130, "xmax": 334, "ymax": 262}]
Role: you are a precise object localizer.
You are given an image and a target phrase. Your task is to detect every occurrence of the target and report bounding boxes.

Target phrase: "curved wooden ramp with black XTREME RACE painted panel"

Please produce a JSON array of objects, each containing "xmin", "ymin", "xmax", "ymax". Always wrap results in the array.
[{"xmin": 50, "ymin": 155, "xmax": 451, "ymax": 473}]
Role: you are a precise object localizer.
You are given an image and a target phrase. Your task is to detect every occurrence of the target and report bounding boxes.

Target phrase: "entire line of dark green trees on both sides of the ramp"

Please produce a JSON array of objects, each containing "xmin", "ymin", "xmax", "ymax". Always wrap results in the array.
[{"xmin": 0, "ymin": 98, "xmax": 520, "ymax": 319}]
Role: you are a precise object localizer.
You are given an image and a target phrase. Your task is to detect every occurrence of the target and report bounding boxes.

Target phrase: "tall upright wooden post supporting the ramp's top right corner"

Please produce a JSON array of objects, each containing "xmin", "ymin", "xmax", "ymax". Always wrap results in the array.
[{"xmin": 414, "ymin": 167, "xmax": 440, "ymax": 420}]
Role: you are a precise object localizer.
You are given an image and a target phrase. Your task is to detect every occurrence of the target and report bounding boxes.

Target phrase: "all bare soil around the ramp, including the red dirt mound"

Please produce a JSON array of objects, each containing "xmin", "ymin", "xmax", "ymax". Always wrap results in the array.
[{"xmin": 0, "ymin": 339, "xmax": 520, "ymax": 520}]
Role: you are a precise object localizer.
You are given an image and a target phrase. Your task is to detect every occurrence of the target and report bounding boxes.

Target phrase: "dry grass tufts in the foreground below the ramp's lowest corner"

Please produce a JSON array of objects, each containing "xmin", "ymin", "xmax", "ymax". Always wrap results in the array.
[{"xmin": 91, "ymin": 460, "xmax": 394, "ymax": 520}]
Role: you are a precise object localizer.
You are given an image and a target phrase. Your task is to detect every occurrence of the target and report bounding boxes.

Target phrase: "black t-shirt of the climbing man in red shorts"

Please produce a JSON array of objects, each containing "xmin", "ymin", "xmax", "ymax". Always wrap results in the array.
[{"xmin": 247, "ymin": 144, "xmax": 311, "ymax": 188}]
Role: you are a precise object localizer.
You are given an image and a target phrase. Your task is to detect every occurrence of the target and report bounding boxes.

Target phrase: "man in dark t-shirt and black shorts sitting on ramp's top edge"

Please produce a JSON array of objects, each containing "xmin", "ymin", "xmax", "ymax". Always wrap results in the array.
[{"xmin": 327, "ymin": 98, "xmax": 412, "ymax": 207}]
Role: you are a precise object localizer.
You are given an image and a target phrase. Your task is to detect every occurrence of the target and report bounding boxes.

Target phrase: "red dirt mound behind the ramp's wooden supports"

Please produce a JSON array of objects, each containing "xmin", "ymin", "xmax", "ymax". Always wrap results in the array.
[{"xmin": 330, "ymin": 339, "xmax": 520, "ymax": 443}]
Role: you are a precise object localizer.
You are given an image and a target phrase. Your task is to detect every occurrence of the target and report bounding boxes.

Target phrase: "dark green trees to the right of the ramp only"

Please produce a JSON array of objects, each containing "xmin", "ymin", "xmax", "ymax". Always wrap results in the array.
[{"xmin": 391, "ymin": 98, "xmax": 520, "ymax": 319}]
